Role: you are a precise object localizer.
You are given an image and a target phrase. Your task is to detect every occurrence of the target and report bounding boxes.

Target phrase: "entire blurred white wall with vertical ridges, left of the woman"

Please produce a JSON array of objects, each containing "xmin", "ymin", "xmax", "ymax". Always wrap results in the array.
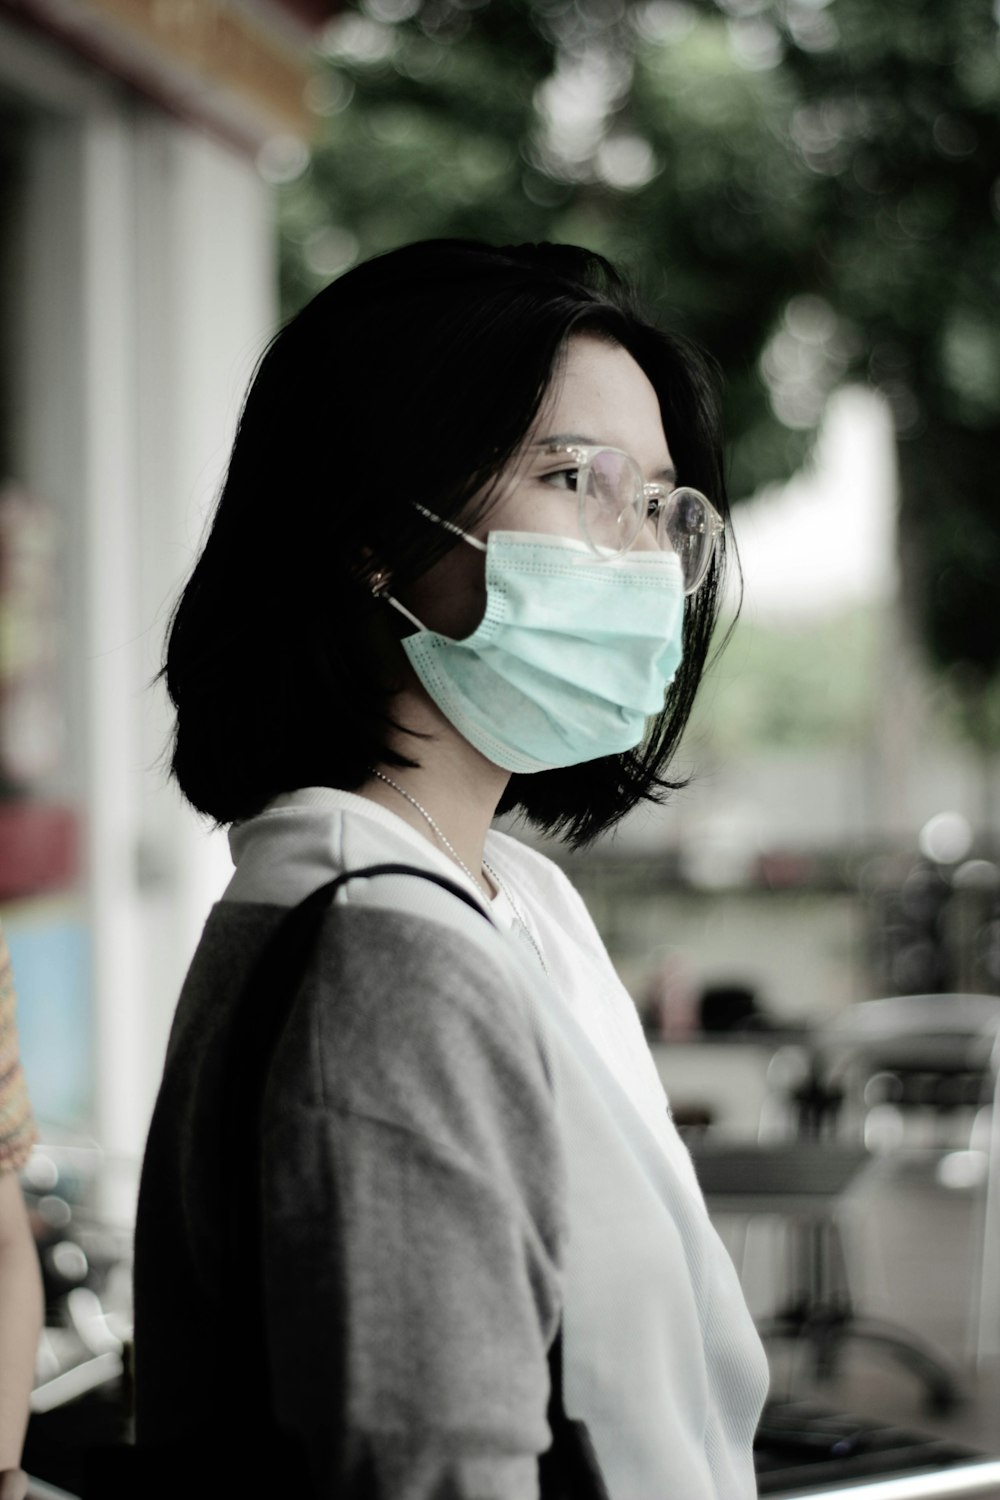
[{"xmin": 0, "ymin": 23, "xmax": 276, "ymax": 1176}]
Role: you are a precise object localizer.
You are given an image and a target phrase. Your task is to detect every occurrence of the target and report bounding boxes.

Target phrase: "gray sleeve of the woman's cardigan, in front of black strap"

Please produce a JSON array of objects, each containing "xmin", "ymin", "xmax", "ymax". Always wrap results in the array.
[{"xmin": 257, "ymin": 909, "xmax": 565, "ymax": 1500}]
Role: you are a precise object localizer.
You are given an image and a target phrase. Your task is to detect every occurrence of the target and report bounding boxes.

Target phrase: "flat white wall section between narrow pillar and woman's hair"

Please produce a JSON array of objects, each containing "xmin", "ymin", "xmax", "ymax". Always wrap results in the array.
[{"xmin": 135, "ymin": 116, "xmax": 276, "ymax": 1152}]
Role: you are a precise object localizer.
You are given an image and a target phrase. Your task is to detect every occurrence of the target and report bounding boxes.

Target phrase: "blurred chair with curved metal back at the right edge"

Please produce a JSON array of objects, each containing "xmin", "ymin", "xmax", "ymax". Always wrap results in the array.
[{"xmin": 696, "ymin": 995, "xmax": 1000, "ymax": 1409}]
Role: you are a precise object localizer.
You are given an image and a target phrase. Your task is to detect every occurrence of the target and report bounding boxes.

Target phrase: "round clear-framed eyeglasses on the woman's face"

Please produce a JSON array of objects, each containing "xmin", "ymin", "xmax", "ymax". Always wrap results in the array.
[{"xmin": 540, "ymin": 443, "xmax": 726, "ymax": 594}]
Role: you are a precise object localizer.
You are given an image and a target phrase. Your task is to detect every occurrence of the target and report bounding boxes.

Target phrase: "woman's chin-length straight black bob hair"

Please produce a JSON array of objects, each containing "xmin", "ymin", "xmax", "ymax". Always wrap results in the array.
[{"xmin": 163, "ymin": 240, "xmax": 729, "ymax": 848}]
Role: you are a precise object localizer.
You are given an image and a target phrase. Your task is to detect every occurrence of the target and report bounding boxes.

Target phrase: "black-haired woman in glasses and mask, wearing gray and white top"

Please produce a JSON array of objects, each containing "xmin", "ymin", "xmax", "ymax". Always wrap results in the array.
[{"xmin": 136, "ymin": 242, "xmax": 766, "ymax": 1500}]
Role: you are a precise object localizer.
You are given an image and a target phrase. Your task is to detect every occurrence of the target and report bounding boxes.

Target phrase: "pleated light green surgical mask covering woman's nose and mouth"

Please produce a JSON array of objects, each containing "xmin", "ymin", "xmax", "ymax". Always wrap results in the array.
[{"xmin": 382, "ymin": 518, "xmax": 684, "ymax": 771}]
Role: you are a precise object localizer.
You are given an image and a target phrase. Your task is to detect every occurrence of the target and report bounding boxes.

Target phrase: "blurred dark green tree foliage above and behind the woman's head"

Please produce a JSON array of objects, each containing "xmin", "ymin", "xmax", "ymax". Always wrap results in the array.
[{"xmin": 282, "ymin": 0, "xmax": 1000, "ymax": 741}]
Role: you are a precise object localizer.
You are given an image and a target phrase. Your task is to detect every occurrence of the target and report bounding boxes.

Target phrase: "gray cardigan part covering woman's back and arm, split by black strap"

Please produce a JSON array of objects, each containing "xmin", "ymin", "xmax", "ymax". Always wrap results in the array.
[{"xmin": 135, "ymin": 902, "xmax": 565, "ymax": 1500}]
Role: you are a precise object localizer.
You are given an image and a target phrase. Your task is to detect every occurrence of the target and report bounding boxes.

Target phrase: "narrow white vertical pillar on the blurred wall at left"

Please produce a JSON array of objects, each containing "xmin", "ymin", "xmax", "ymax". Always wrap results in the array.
[{"xmin": 79, "ymin": 108, "xmax": 144, "ymax": 1181}]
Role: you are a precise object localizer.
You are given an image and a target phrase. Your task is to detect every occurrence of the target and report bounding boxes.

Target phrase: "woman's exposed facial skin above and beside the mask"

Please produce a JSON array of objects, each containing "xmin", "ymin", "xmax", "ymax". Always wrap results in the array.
[{"xmin": 400, "ymin": 335, "xmax": 676, "ymax": 641}]
